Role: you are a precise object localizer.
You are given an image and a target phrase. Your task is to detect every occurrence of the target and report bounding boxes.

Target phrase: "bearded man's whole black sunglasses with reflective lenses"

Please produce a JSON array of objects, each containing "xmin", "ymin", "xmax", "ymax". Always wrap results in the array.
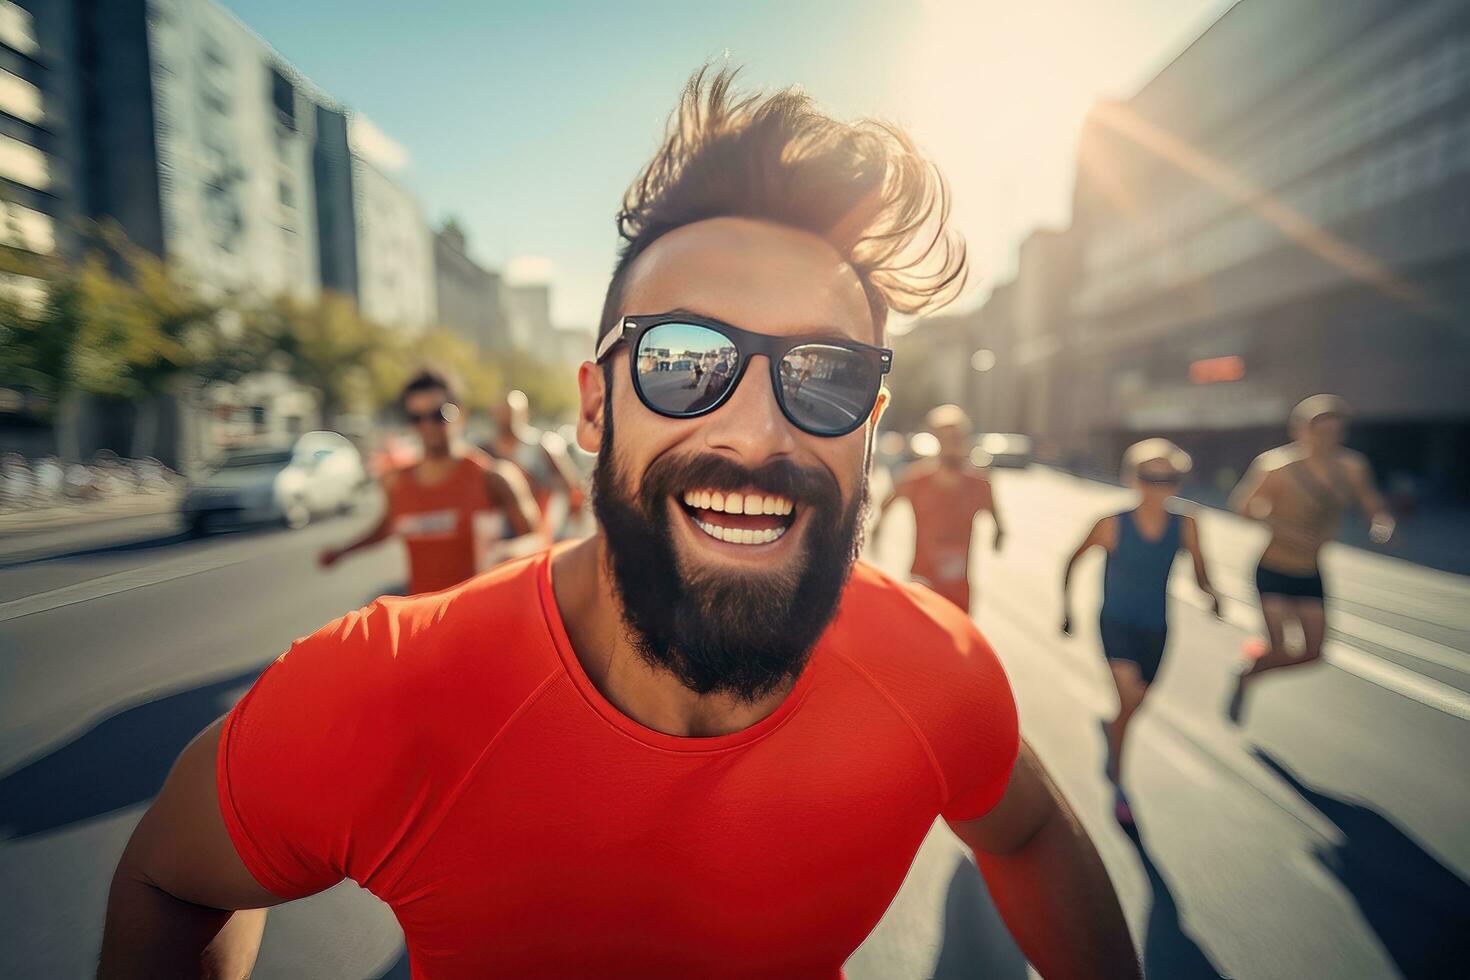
[{"xmin": 597, "ymin": 313, "xmax": 894, "ymax": 436}]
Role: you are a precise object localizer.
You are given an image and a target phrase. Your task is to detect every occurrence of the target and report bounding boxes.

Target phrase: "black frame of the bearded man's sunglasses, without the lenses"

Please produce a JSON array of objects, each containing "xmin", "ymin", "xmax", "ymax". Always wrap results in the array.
[{"xmin": 595, "ymin": 311, "xmax": 894, "ymax": 439}]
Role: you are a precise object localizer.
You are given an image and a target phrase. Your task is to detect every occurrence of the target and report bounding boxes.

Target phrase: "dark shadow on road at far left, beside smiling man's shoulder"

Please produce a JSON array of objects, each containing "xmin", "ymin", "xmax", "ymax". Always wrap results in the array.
[{"xmin": 0, "ymin": 667, "xmax": 263, "ymax": 840}]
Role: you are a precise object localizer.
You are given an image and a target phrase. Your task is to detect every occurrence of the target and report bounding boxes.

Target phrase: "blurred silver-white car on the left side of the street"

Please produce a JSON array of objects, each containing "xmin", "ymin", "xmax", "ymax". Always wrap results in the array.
[{"xmin": 182, "ymin": 432, "xmax": 368, "ymax": 533}]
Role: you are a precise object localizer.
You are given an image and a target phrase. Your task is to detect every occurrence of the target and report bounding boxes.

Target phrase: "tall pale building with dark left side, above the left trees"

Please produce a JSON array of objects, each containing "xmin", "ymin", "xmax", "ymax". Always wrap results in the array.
[{"xmin": 74, "ymin": 0, "xmax": 320, "ymax": 297}]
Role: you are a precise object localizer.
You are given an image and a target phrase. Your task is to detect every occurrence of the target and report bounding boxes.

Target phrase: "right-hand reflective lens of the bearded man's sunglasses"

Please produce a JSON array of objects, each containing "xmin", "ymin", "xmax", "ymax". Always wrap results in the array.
[{"xmin": 781, "ymin": 344, "xmax": 882, "ymax": 435}]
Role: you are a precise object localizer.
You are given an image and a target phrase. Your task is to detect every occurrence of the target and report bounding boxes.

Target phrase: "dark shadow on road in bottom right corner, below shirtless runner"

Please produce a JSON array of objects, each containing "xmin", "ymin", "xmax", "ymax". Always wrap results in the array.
[{"xmin": 1251, "ymin": 748, "xmax": 1470, "ymax": 977}]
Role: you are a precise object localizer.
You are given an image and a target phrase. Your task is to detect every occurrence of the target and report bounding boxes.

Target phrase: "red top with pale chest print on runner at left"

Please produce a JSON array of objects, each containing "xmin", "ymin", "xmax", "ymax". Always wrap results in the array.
[{"xmin": 387, "ymin": 450, "xmax": 495, "ymax": 595}]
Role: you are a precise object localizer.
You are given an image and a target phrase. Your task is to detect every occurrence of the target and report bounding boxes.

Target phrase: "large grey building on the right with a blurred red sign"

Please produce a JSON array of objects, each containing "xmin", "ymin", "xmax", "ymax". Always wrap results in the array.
[{"xmin": 1058, "ymin": 0, "xmax": 1470, "ymax": 500}]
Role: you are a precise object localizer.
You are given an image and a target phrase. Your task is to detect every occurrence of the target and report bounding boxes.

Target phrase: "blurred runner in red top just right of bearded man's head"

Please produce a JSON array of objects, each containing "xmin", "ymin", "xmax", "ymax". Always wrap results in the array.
[{"xmin": 873, "ymin": 406, "xmax": 1005, "ymax": 613}]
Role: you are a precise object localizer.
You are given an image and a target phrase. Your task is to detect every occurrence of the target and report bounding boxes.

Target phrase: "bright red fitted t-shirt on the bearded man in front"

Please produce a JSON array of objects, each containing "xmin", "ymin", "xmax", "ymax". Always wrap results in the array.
[{"xmin": 216, "ymin": 552, "xmax": 1017, "ymax": 979}]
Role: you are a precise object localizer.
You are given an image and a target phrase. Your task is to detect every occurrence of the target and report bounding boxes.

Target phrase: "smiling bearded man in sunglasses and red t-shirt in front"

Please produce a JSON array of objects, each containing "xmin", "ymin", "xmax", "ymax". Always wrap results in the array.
[{"xmin": 101, "ymin": 73, "xmax": 1136, "ymax": 977}]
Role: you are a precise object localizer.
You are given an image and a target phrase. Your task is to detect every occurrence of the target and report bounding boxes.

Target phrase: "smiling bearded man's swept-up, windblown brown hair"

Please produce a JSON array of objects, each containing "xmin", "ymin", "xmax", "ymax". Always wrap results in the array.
[{"xmin": 598, "ymin": 66, "xmax": 966, "ymax": 345}]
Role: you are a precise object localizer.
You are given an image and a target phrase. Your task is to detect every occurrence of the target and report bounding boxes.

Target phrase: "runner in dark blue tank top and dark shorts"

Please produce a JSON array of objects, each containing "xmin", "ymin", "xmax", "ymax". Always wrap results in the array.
[{"xmin": 1061, "ymin": 439, "xmax": 1220, "ymax": 826}]
